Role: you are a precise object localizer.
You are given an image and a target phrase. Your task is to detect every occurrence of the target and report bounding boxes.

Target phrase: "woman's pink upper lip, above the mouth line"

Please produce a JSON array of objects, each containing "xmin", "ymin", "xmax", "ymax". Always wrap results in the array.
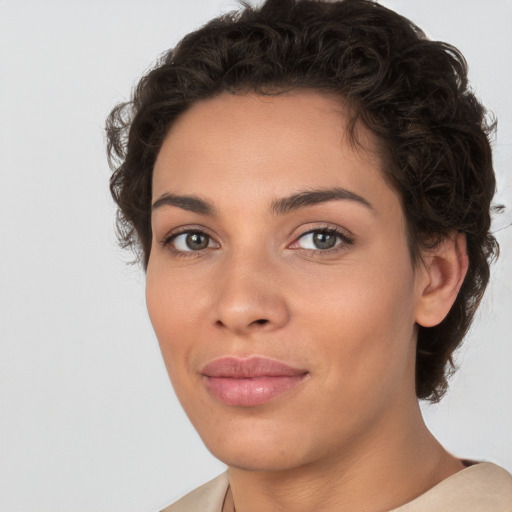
[{"xmin": 201, "ymin": 356, "xmax": 307, "ymax": 379}]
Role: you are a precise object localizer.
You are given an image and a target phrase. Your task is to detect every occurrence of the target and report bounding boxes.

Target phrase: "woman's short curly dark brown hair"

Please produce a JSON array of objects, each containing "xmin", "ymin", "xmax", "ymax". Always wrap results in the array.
[{"xmin": 107, "ymin": 0, "xmax": 498, "ymax": 401}]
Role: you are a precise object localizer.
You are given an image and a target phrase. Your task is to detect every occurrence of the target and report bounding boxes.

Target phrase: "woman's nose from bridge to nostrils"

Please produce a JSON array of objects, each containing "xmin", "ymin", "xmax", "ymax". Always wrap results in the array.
[{"xmin": 213, "ymin": 251, "xmax": 290, "ymax": 335}]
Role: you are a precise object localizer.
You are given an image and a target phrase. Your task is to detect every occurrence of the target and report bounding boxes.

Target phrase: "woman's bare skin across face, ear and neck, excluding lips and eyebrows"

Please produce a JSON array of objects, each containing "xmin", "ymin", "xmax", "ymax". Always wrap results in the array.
[{"xmin": 146, "ymin": 91, "xmax": 467, "ymax": 512}]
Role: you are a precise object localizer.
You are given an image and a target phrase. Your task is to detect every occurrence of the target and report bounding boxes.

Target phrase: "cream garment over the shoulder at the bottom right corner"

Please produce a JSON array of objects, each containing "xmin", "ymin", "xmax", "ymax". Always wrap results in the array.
[{"xmin": 392, "ymin": 462, "xmax": 512, "ymax": 512}]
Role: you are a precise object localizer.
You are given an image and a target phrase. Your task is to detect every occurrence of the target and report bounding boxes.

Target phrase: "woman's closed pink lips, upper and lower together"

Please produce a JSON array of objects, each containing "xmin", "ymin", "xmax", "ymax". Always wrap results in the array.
[{"xmin": 201, "ymin": 357, "xmax": 308, "ymax": 407}]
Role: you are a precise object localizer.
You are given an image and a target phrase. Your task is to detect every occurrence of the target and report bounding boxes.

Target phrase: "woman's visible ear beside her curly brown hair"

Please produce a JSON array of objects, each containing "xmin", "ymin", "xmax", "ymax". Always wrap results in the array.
[{"xmin": 415, "ymin": 233, "xmax": 468, "ymax": 327}]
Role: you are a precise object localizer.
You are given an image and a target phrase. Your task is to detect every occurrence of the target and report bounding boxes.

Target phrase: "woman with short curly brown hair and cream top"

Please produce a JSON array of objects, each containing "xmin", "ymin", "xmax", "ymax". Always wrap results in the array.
[{"xmin": 108, "ymin": 0, "xmax": 512, "ymax": 512}]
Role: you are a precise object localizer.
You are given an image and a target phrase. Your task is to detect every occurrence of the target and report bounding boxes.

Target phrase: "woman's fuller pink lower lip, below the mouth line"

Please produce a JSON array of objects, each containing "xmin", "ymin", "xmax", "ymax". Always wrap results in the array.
[{"xmin": 203, "ymin": 375, "xmax": 305, "ymax": 407}]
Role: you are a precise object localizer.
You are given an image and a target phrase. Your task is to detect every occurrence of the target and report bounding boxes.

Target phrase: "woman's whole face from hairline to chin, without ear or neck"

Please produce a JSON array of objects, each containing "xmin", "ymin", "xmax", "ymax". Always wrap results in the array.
[{"xmin": 147, "ymin": 92, "xmax": 419, "ymax": 470}]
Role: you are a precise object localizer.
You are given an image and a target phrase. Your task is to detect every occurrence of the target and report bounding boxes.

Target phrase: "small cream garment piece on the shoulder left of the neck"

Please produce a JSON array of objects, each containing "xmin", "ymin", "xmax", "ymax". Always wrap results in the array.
[{"xmin": 161, "ymin": 472, "xmax": 229, "ymax": 512}]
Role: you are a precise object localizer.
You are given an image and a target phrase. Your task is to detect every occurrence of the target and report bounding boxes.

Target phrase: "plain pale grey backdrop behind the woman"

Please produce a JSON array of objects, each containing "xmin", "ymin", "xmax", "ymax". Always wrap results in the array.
[{"xmin": 0, "ymin": 0, "xmax": 512, "ymax": 512}]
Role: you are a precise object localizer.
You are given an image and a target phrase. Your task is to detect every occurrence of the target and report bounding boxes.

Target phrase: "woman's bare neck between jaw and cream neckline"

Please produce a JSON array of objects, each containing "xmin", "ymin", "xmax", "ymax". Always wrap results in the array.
[{"xmin": 225, "ymin": 401, "xmax": 463, "ymax": 512}]
